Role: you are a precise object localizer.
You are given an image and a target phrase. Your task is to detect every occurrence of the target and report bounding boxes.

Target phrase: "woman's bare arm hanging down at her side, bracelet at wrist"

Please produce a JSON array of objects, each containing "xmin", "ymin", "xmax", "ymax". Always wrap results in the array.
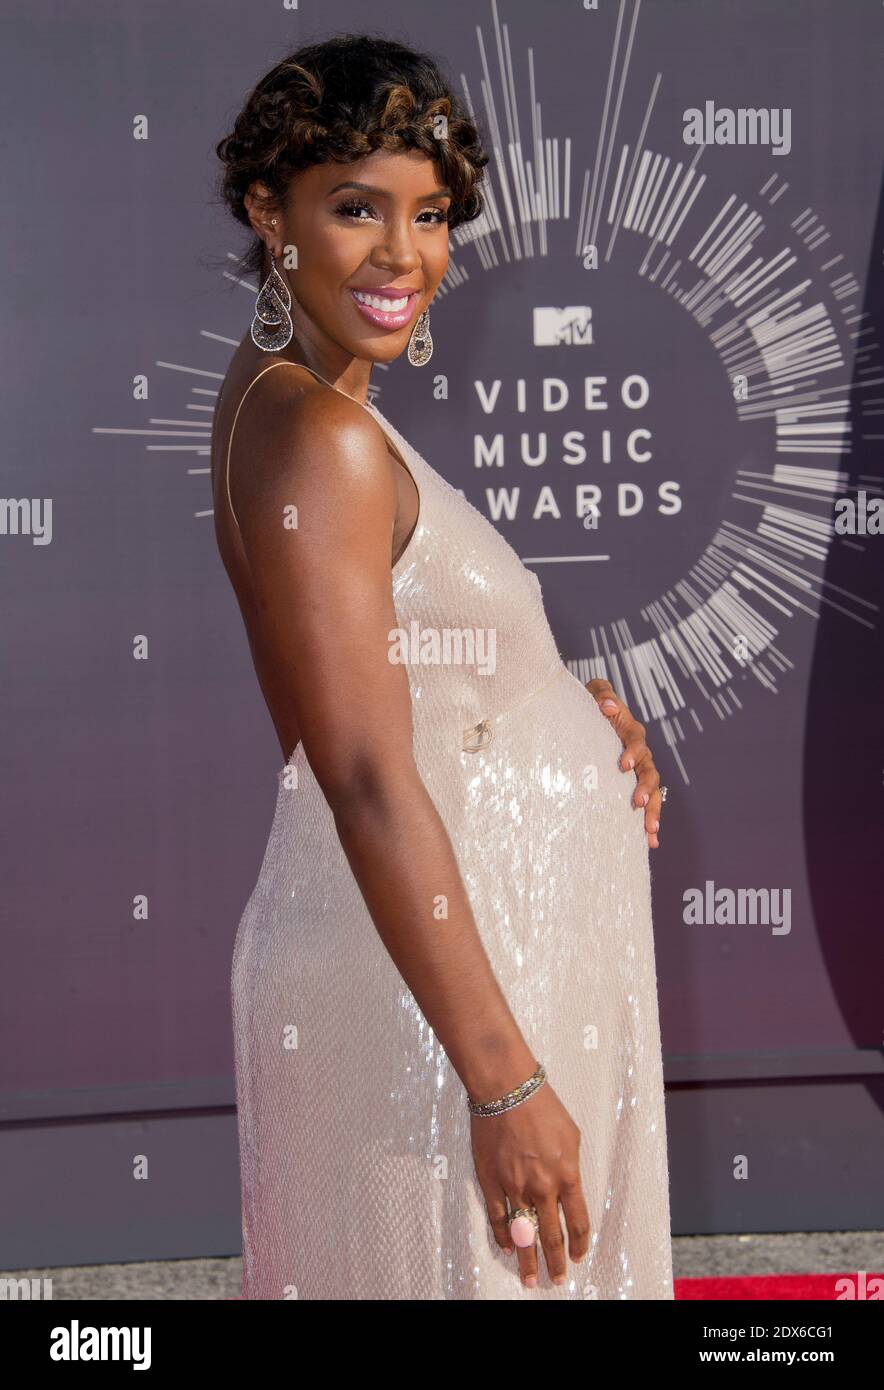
[{"xmin": 231, "ymin": 373, "xmax": 580, "ymax": 1272}]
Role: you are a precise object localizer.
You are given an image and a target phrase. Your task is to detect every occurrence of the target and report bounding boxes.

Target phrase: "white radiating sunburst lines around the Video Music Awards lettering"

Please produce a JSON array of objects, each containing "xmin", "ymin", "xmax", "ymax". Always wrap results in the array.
[{"xmin": 95, "ymin": 0, "xmax": 884, "ymax": 783}]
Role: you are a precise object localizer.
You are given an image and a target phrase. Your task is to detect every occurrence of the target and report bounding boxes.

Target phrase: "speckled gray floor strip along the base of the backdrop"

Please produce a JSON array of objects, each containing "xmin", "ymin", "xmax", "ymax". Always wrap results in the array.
[{"xmin": 4, "ymin": 1232, "xmax": 884, "ymax": 1301}]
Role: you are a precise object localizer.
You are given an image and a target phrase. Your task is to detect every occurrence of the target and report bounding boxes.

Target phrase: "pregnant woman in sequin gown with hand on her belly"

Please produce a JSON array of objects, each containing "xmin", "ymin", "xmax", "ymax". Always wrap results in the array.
[{"xmin": 213, "ymin": 36, "xmax": 673, "ymax": 1300}]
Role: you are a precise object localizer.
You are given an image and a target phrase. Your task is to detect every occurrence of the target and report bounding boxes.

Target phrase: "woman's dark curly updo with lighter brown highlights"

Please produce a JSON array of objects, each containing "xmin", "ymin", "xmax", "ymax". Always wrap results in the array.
[{"xmin": 215, "ymin": 33, "xmax": 488, "ymax": 278}]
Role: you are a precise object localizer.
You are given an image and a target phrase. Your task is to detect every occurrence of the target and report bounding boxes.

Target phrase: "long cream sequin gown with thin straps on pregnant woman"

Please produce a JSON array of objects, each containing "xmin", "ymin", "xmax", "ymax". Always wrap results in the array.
[{"xmin": 232, "ymin": 363, "xmax": 673, "ymax": 1301}]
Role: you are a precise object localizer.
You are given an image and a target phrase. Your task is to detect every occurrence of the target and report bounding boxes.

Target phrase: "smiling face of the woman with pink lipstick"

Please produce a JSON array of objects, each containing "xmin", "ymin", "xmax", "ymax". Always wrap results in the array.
[{"xmin": 254, "ymin": 150, "xmax": 452, "ymax": 361}]
